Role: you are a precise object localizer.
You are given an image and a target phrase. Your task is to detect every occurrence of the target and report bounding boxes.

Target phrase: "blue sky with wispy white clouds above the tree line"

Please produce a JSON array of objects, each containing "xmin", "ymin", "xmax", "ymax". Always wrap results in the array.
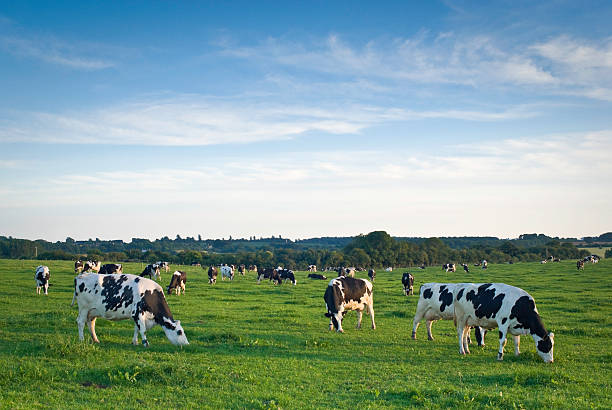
[{"xmin": 0, "ymin": 0, "xmax": 612, "ymax": 241}]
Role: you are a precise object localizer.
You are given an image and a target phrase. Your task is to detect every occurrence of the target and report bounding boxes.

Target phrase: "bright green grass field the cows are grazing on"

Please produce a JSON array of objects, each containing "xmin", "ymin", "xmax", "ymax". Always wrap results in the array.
[{"xmin": 0, "ymin": 259, "xmax": 612, "ymax": 409}]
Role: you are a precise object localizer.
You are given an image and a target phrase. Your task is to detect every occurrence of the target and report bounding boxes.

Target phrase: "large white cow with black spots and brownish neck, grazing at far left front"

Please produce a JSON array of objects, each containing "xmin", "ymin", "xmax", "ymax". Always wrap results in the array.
[{"xmin": 71, "ymin": 273, "xmax": 189, "ymax": 347}]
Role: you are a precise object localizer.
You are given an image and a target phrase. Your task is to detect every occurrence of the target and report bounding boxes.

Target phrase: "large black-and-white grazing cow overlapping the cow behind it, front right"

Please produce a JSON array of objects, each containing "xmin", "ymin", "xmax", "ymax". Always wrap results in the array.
[{"xmin": 455, "ymin": 283, "xmax": 555, "ymax": 363}]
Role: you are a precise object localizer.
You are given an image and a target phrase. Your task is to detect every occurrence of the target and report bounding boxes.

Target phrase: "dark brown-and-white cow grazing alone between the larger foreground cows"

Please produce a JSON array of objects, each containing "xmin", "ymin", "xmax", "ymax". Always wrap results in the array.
[{"xmin": 323, "ymin": 276, "xmax": 376, "ymax": 333}]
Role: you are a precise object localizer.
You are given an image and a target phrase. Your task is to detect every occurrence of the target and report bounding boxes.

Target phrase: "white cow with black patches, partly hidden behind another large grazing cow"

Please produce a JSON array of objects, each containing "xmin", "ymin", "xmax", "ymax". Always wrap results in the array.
[{"xmin": 412, "ymin": 283, "xmax": 486, "ymax": 346}]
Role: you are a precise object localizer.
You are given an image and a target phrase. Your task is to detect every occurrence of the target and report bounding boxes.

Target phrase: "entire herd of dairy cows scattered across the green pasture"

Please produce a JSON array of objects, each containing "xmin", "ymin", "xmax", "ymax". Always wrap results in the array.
[{"xmin": 29, "ymin": 258, "xmax": 568, "ymax": 363}]
